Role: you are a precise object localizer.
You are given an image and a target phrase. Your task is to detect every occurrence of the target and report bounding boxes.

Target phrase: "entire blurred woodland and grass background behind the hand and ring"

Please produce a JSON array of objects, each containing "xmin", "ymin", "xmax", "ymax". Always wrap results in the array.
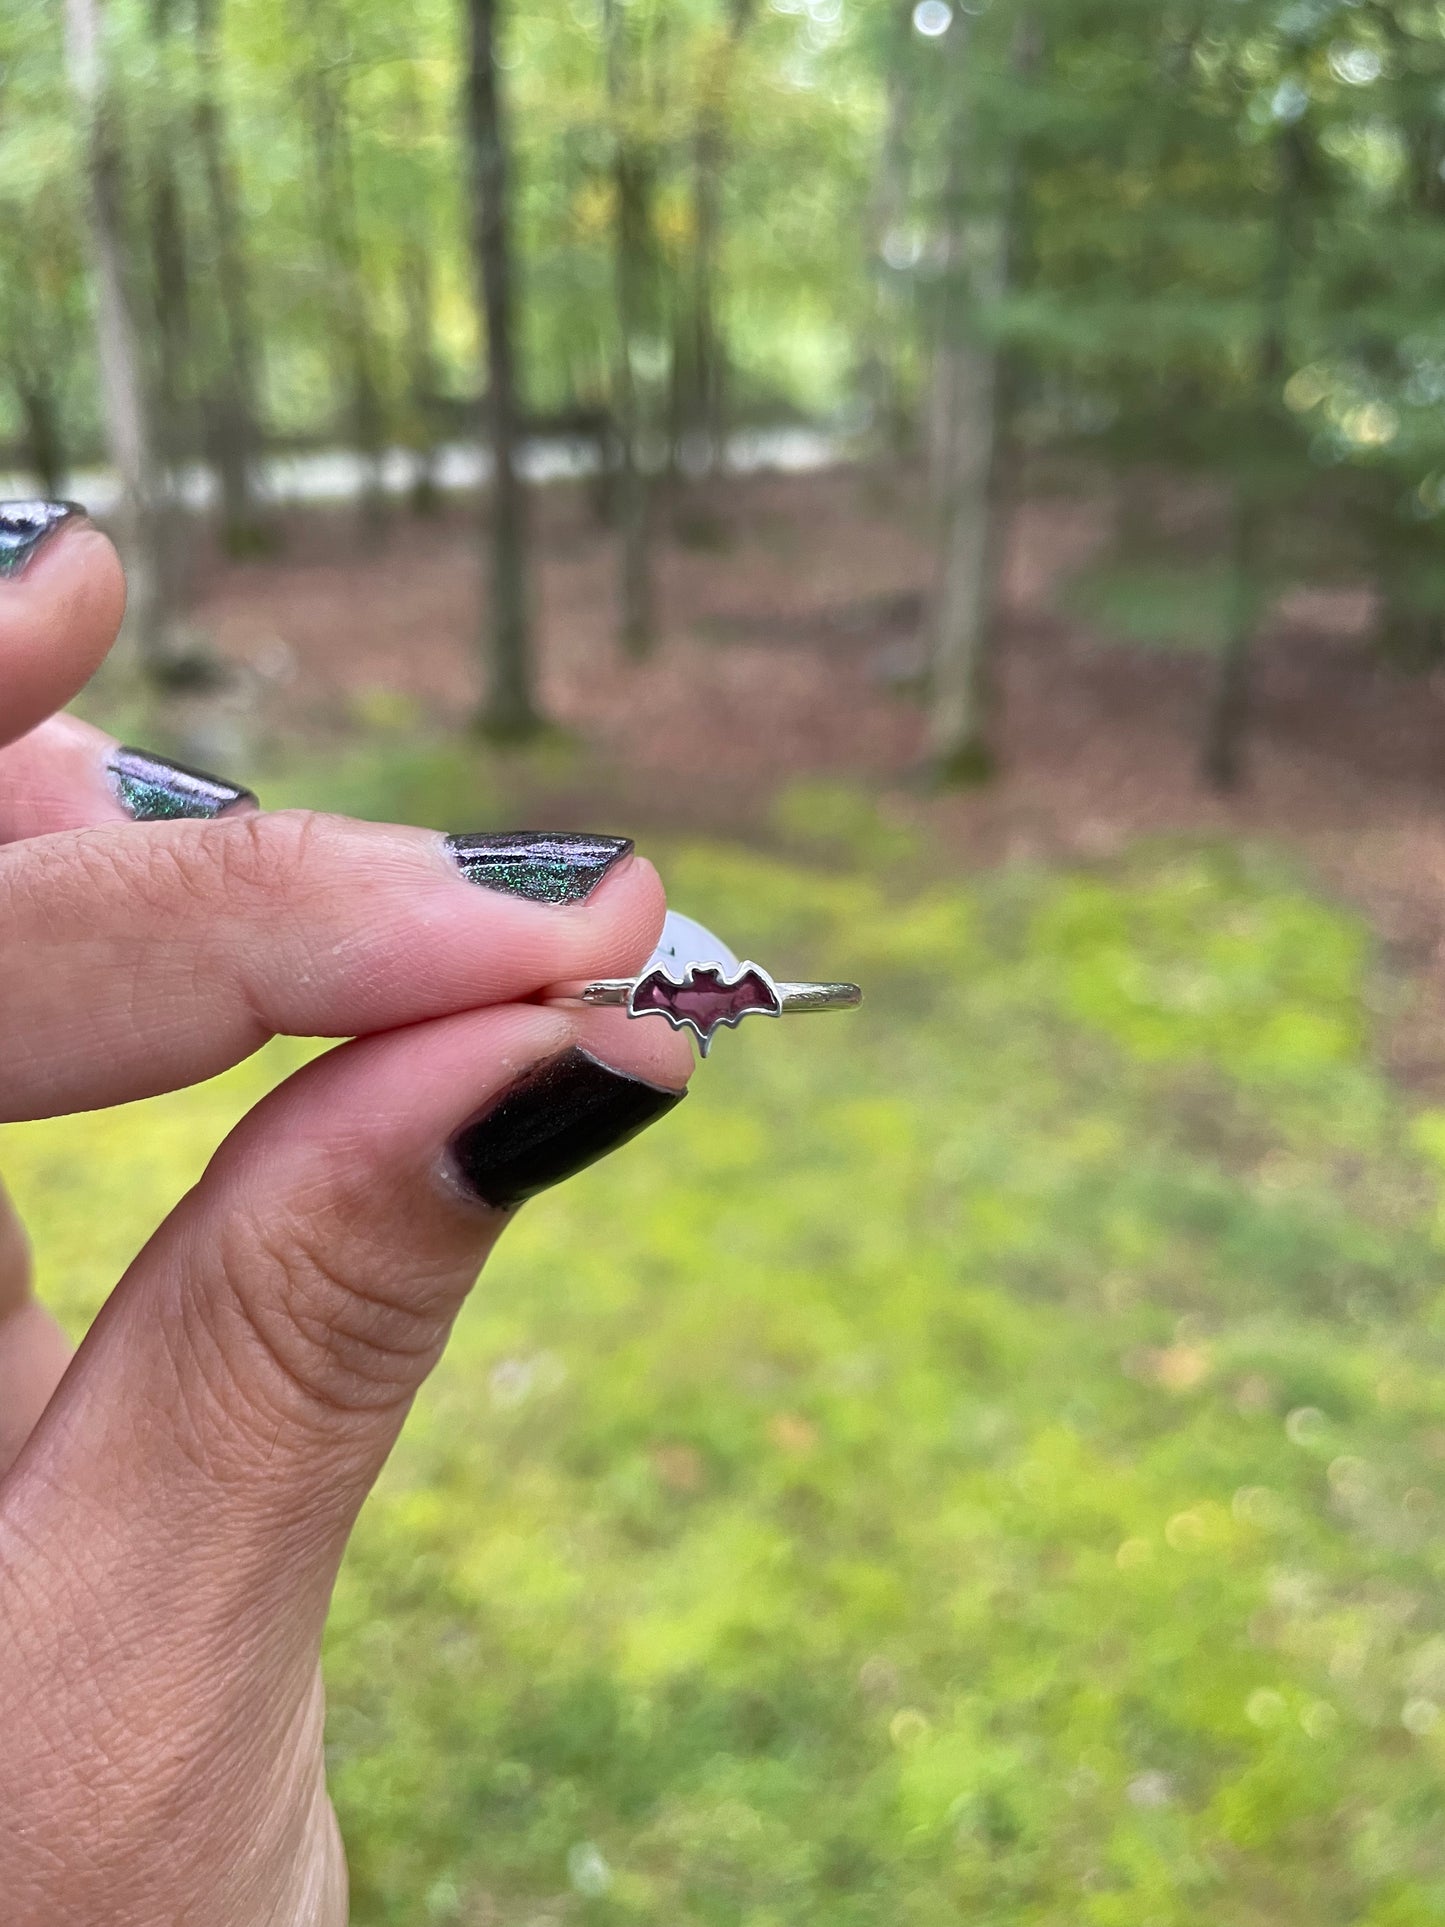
[{"xmin": 0, "ymin": 0, "xmax": 1445, "ymax": 1927}]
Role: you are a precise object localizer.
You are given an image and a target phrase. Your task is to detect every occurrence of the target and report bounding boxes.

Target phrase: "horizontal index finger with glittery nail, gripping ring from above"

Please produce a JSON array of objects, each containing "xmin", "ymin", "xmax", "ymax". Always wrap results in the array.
[{"xmin": 0, "ymin": 811, "xmax": 665, "ymax": 1118}]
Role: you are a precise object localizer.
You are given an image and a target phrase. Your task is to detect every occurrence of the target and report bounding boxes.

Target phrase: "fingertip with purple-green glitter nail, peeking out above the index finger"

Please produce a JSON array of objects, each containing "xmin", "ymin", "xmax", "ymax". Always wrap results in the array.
[{"xmin": 0, "ymin": 715, "xmax": 256, "ymax": 844}]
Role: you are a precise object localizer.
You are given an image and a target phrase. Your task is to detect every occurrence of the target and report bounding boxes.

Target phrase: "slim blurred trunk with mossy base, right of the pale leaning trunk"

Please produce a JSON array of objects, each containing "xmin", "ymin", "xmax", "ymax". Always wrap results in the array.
[{"xmin": 195, "ymin": 0, "xmax": 274, "ymax": 555}]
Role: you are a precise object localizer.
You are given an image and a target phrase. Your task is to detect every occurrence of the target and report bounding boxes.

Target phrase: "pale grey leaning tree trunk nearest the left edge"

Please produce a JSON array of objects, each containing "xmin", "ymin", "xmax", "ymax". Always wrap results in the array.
[{"xmin": 66, "ymin": 0, "xmax": 177, "ymax": 680}]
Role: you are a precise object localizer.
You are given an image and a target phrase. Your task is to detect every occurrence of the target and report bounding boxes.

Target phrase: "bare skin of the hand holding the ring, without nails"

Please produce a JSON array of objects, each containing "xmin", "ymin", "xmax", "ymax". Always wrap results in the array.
[{"xmin": 0, "ymin": 524, "xmax": 692, "ymax": 1927}]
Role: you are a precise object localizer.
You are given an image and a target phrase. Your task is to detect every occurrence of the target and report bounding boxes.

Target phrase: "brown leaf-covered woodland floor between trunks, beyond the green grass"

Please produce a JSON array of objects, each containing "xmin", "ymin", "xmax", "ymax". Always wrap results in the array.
[{"xmin": 183, "ymin": 456, "xmax": 1445, "ymax": 1095}]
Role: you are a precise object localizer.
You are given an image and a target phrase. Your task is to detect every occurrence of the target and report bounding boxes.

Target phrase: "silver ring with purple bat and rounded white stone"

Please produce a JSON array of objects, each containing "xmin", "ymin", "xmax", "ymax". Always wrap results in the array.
[{"xmin": 553, "ymin": 910, "xmax": 863, "ymax": 1056}]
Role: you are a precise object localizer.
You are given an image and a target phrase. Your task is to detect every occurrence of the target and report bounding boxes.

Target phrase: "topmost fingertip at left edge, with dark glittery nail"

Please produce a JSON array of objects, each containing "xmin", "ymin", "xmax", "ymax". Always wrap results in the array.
[{"xmin": 0, "ymin": 501, "xmax": 125, "ymax": 742}]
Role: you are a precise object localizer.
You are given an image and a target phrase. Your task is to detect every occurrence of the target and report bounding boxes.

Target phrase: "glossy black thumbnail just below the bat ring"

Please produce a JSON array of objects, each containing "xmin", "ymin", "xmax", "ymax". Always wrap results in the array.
[{"xmin": 451, "ymin": 1050, "xmax": 688, "ymax": 1210}]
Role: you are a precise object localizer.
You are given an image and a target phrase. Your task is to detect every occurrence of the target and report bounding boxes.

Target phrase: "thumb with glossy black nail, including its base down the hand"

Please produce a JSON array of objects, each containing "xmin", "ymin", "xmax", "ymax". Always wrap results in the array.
[{"xmin": 0, "ymin": 1006, "xmax": 690, "ymax": 1919}]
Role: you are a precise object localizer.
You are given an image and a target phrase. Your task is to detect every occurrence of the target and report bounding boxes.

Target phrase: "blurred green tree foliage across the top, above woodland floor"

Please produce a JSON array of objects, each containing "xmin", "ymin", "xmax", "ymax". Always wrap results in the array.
[{"xmin": 0, "ymin": 0, "xmax": 1445, "ymax": 663}]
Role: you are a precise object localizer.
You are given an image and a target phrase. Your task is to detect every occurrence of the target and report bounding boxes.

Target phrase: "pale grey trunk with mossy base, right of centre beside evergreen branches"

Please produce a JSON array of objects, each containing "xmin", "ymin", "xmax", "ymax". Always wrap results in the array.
[{"xmin": 929, "ymin": 13, "xmax": 1037, "ymax": 782}]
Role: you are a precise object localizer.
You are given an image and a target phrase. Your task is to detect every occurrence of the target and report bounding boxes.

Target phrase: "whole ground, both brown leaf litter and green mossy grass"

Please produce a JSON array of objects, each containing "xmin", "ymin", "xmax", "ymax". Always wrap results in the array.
[{"xmin": 19, "ymin": 474, "xmax": 1445, "ymax": 1927}]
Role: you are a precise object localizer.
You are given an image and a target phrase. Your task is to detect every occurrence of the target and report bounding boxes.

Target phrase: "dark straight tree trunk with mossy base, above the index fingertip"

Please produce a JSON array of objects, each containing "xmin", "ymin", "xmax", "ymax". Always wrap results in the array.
[{"xmin": 466, "ymin": 0, "xmax": 541, "ymax": 740}]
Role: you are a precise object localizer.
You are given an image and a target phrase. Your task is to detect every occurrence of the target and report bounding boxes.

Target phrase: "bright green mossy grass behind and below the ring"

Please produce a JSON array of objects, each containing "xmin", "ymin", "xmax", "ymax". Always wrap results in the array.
[{"xmin": 0, "ymin": 817, "xmax": 1445, "ymax": 1927}]
